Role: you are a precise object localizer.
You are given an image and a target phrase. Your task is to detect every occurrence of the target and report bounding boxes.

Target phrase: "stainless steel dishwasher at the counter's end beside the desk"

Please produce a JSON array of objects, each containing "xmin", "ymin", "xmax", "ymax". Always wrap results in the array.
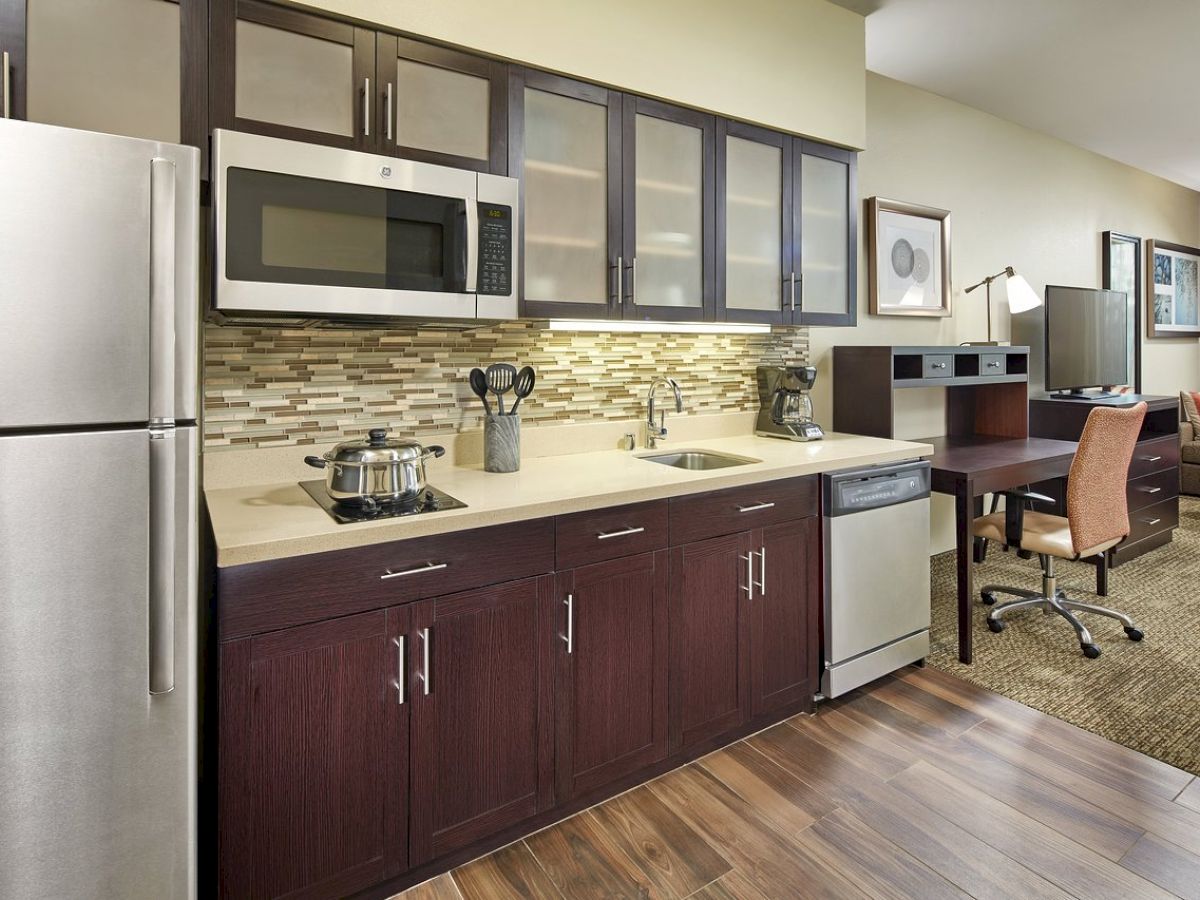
[{"xmin": 821, "ymin": 462, "xmax": 930, "ymax": 697}]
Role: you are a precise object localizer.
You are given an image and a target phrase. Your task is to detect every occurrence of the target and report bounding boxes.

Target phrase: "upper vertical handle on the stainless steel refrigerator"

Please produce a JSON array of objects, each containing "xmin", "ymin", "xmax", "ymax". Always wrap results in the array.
[{"xmin": 149, "ymin": 156, "xmax": 176, "ymax": 425}]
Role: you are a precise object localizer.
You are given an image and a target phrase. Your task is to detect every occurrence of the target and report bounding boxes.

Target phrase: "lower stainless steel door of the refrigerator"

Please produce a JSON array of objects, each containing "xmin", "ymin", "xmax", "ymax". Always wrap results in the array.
[{"xmin": 0, "ymin": 428, "xmax": 197, "ymax": 900}]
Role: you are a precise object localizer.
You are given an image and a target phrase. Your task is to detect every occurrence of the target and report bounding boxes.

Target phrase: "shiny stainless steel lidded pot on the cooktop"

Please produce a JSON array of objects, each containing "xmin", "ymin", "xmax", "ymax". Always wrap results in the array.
[{"xmin": 304, "ymin": 428, "xmax": 445, "ymax": 509}]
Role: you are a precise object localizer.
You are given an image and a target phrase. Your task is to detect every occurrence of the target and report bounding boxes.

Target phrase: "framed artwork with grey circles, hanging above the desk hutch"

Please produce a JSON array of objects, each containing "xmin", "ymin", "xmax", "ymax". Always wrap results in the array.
[{"xmin": 866, "ymin": 197, "xmax": 950, "ymax": 316}]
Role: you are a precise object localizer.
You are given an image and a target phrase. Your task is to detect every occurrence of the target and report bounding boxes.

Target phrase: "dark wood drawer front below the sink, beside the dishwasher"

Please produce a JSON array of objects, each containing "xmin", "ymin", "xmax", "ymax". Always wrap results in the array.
[{"xmin": 670, "ymin": 475, "xmax": 817, "ymax": 547}]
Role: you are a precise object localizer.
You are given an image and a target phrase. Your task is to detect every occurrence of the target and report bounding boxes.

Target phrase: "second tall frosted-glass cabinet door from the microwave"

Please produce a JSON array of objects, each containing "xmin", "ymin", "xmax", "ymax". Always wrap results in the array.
[{"xmin": 622, "ymin": 97, "xmax": 715, "ymax": 320}]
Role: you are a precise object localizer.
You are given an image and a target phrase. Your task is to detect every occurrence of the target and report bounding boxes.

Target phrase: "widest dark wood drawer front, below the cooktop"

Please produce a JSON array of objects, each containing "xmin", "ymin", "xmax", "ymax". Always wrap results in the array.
[{"xmin": 217, "ymin": 518, "xmax": 554, "ymax": 640}]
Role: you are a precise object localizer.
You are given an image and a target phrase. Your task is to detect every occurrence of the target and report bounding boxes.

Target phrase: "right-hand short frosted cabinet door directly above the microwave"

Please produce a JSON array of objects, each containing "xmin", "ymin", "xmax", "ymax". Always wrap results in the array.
[{"xmin": 376, "ymin": 32, "xmax": 509, "ymax": 175}]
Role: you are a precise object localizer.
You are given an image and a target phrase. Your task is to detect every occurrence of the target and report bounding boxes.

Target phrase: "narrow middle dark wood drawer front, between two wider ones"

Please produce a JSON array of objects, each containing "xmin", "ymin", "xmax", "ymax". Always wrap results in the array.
[{"xmin": 554, "ymin": 500, "xmax": 667, "ymax": 571}]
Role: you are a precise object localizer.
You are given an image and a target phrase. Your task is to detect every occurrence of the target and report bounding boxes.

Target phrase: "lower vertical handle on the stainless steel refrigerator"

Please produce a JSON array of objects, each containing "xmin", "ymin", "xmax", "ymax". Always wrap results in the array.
[{"xmin": 149, "ymin": 426, "xmax": 175, "ymax": 694}]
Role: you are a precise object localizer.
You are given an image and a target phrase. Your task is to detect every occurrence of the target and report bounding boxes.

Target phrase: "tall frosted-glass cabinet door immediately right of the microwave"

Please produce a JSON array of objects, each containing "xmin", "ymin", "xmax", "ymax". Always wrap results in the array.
[{"xmin": 509, "ymin": 67, "xmax": 624, "ymax": 319}]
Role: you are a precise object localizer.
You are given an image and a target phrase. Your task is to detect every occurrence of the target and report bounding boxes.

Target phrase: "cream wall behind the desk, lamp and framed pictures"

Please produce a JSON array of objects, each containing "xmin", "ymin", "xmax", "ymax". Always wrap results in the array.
[{"xmin": 809, "ymin": 73, "xmax": 1200, "ymax": 552}]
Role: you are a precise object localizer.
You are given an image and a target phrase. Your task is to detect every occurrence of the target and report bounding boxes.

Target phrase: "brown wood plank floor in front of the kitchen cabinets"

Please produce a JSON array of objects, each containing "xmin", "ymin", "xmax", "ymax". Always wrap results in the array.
[{"xmin": 388, "ymin": 668, "xmax": 1200, "ymax": 900}]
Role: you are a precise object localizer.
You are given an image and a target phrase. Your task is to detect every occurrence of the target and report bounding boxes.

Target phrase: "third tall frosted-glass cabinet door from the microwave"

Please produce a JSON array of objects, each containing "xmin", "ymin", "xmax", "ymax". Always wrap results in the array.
[{"xmin": 716, "ymin": 121, "xmax": 793, "ymax": 325}]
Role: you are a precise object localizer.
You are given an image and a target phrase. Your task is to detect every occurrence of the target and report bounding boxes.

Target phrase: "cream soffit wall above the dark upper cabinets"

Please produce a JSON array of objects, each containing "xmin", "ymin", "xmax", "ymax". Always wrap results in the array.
[{"xmin": 295, "ymin": 0, "xmax": 865, "ymax": 148}]
